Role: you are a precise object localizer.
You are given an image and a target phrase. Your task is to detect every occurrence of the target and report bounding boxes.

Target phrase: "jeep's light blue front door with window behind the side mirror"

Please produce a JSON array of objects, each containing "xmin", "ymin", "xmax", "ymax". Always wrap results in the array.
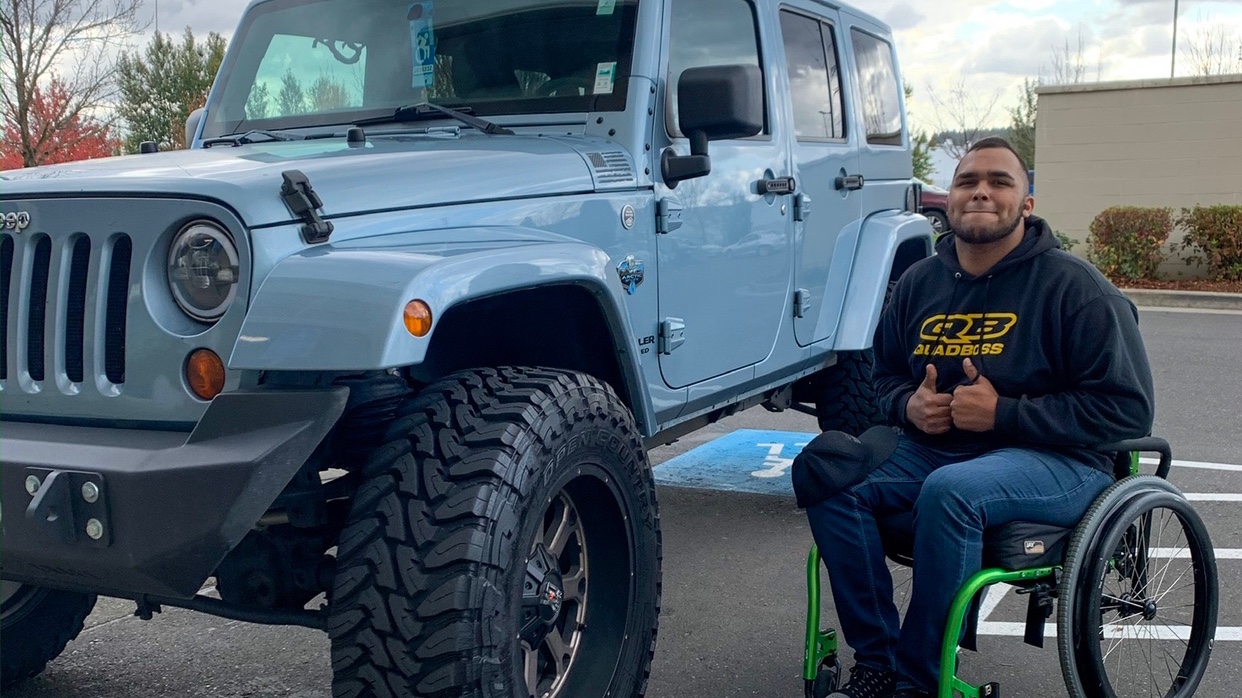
[{"xmin": 656, "ymin": 0, "xmax": 792, "ymax": 388}]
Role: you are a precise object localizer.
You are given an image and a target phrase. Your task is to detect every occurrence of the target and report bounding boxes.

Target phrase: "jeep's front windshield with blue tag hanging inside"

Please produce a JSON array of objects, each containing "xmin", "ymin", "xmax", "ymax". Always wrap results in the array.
[{"xmin": 202, "ymin": 0, "xmax": 638, "ymax": 138}]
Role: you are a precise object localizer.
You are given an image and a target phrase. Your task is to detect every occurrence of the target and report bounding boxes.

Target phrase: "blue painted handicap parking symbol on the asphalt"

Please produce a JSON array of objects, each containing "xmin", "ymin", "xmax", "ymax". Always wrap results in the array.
[{"xmin": 655, "ymin": 428, "xmax": 815, "ymax": 497}]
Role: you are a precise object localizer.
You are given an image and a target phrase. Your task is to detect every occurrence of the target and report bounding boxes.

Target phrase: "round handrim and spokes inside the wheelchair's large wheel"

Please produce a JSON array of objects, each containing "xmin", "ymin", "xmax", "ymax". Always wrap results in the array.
[{"xmin": 1083, "ymin": 496, "xmax": 1210, "ymax": 697}]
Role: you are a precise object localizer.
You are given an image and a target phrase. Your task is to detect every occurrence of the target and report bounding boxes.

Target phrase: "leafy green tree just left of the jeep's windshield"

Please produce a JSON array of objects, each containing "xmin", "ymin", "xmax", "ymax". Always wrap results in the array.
[{"xmin": 117, "ymin": 27, "xmax": 225, "ymax": 153}]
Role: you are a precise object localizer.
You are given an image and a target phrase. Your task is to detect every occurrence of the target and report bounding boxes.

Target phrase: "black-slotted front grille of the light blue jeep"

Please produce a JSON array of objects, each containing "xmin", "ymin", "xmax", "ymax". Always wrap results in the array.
[{"xmin": 0, "ymin": 233, "xmax": 133, "ymax": 392}]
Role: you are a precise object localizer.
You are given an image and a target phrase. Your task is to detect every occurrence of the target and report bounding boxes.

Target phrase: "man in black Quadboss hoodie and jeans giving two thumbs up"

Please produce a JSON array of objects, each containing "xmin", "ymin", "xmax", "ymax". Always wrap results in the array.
[{"xmin": 807, "ymin": 138, "xmax": 1154, "ymax": 698}]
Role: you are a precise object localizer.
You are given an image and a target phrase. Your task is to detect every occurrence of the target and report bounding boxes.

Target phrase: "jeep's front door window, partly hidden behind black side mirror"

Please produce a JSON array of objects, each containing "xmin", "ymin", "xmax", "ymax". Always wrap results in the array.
[{"xmin": 666, "ymin": 0, "xmax": 768, "ymax": 138}]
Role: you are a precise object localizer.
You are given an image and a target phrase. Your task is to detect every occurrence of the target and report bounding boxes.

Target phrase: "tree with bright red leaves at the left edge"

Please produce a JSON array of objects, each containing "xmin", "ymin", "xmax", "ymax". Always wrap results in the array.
[{"xmin": 0, "ymin": 77, "xmax": 120, "ymax": 170}]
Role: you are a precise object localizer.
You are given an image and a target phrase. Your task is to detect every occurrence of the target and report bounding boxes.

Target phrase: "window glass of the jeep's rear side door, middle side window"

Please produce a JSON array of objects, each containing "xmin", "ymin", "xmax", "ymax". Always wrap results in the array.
[{"xmin": 780, "ymin": 10, "xmax": 846, "ymax": 140}]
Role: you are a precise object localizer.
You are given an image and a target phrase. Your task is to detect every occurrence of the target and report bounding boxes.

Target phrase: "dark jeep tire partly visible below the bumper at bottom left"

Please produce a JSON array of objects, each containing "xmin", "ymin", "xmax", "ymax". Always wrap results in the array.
[{"xmin": 0, "ymin": 582, "xmax": 94, "ymax": 688}]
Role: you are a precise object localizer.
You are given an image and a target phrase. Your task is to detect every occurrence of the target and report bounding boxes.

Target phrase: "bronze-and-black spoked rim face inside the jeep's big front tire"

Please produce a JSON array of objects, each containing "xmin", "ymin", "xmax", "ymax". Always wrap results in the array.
[{"xmin": 522, "ymin": 489, "xmax": 590, "ymax": 698}]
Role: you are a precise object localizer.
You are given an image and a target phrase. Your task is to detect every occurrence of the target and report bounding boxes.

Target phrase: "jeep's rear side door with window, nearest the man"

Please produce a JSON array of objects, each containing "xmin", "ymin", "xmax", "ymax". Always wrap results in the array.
[{"xmin": 780, "ymin": 0, "xmax": 863, "ymax": 347}]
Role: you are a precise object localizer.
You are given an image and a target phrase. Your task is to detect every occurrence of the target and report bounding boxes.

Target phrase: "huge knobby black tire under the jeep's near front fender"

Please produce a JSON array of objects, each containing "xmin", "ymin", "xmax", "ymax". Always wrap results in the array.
[{"xmin": 329, "ymin": 368, "xmax": 662, "ymax": 698}]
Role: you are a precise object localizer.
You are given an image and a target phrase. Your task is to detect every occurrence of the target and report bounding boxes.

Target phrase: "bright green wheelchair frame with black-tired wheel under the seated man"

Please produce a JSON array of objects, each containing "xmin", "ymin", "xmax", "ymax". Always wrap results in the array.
[{"xmin": 802, "ymin": 437, "xmax": 1218, "ymax": 698}]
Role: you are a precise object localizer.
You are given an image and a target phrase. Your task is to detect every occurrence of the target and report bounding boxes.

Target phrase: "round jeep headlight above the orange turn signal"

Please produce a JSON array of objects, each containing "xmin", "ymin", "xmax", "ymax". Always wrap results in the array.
[{"xmin": 168, "ymin": 221, "xmax": 237, "ymax": 322}]
